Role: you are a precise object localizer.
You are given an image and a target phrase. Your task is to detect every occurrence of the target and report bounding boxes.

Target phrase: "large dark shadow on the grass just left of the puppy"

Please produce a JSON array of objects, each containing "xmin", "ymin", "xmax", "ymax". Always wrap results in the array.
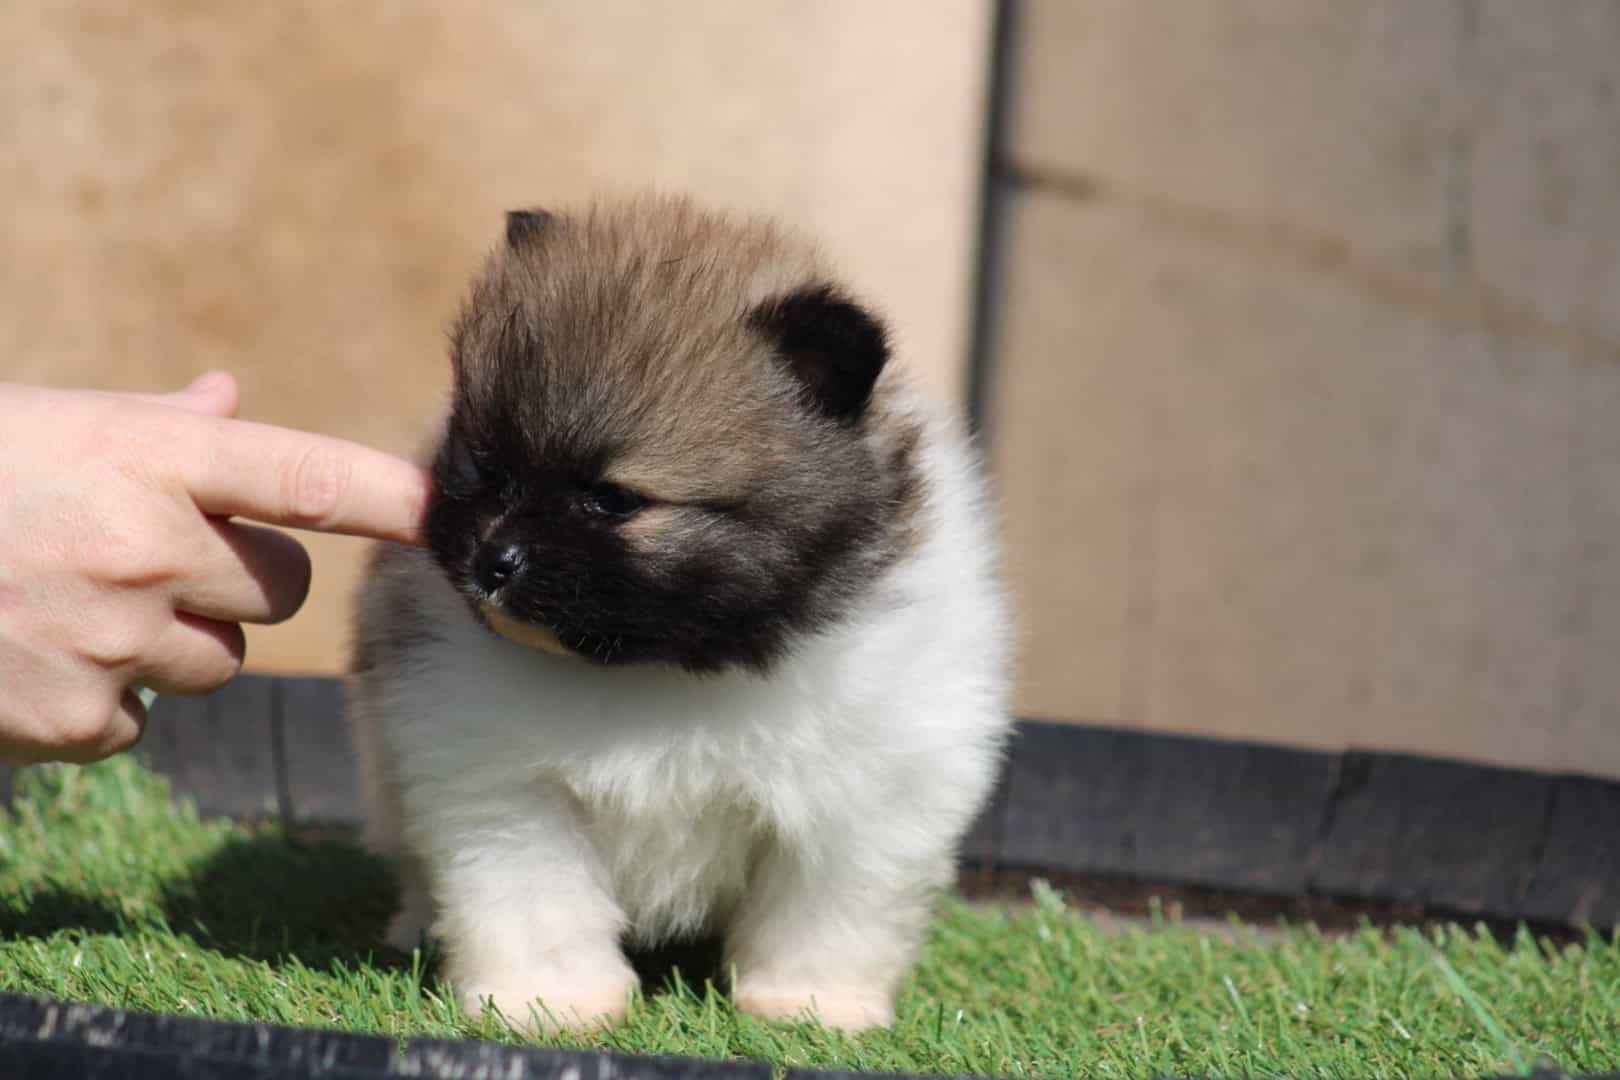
[{"xmin": 162, "ymin": 832, "xmax": 408, "ymax": 970}]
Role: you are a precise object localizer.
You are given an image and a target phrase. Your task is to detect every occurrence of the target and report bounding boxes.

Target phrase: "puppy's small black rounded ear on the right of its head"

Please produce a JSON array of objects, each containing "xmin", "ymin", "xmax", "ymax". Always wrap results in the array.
[{"xmin": 748, "ymin": 285, "xmax": 889, "ymax": 423}]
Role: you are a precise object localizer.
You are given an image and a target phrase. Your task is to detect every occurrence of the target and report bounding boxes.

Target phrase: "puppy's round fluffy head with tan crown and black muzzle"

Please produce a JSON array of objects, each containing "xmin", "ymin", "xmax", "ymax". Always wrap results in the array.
[{"xmin": 428, "ymin": 199, "xmax": 919, "ymax": 672}]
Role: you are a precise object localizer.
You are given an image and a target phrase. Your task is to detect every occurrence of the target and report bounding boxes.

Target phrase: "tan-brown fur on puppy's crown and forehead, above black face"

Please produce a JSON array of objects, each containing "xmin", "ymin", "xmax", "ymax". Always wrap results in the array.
[{"xmin": 454, "ymin": 196, "xmax": 887, "ymax": 504}]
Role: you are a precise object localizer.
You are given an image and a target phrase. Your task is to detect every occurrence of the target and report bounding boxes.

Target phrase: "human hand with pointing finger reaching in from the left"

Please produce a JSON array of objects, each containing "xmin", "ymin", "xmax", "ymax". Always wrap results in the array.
[{"xmin": 0, "ymin": 372, "xmax": 431, "ymax": 763}]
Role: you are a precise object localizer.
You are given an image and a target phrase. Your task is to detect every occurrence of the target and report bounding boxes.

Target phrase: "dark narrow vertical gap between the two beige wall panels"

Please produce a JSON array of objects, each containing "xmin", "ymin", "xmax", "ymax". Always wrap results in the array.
[{"xmin": 967, "ymin": 0, "xmax": 1017, "ymax": 434}]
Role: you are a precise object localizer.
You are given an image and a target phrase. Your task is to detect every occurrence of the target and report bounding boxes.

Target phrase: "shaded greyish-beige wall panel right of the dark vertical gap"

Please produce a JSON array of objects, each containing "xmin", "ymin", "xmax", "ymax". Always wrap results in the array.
[{"xmin": 991, "ymin": 0, "xmax": 1620, "ymax": 776}]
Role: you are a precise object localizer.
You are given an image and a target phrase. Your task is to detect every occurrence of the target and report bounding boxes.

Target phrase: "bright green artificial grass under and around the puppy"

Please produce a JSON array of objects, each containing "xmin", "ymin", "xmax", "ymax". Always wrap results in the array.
[{"xmin": 0, "ymin": 759, "xmax": 1620, "ymax": 1077}]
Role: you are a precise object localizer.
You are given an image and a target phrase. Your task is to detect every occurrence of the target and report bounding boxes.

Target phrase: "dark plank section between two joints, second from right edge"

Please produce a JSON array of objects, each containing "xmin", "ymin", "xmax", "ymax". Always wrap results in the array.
[{"xmin": 1312, "ymin": 753, "xmax": 1554, "ymax": 918}]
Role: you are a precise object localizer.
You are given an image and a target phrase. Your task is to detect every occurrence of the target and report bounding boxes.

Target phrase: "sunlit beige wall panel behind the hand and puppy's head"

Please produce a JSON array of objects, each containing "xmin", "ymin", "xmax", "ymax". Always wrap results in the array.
[{"xmin": 0, "ymin": 0, "xmax": 988, "ymax": 670}]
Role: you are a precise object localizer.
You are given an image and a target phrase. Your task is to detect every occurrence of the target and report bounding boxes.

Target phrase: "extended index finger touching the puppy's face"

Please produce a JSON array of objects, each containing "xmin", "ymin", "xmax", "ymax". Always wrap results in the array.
[{"xmin": 181, "ymin": 416, "xmax": 433, "ymax": 544}]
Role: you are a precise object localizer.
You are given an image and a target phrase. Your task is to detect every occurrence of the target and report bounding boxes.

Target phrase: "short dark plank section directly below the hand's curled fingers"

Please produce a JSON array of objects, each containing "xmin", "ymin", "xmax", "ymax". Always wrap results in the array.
[{"xmin": 139, "ymin": 675, "xmax": 277, "ymax": 818}]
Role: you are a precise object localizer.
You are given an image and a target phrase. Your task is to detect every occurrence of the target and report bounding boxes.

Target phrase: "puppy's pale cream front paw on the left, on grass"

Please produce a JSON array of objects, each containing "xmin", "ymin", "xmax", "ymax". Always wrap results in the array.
[{"xmin": 458, "ymin": 960, "xmax": 638, "ymax": 1035}]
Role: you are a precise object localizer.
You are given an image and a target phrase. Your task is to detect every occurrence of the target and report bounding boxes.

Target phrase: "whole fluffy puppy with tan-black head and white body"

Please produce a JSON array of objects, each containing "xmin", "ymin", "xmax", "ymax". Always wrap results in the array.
[{"xmin": 350, "ymin": 198, "xmax": 1009, "ymax": 1030}]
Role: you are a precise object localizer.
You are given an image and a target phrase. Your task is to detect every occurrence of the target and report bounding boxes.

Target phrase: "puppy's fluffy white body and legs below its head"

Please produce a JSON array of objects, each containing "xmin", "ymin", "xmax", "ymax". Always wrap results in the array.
[{"xmin": 353, "ymin": 403, "xmax": 1008, "ymax": 1028}]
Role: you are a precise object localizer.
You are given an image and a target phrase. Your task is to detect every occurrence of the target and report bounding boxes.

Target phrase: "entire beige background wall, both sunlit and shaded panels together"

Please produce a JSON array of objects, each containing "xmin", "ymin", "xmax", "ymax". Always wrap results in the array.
[{"xmin": 0, "ymin": 0, "xmax": 1620, "ymax": 776}]
